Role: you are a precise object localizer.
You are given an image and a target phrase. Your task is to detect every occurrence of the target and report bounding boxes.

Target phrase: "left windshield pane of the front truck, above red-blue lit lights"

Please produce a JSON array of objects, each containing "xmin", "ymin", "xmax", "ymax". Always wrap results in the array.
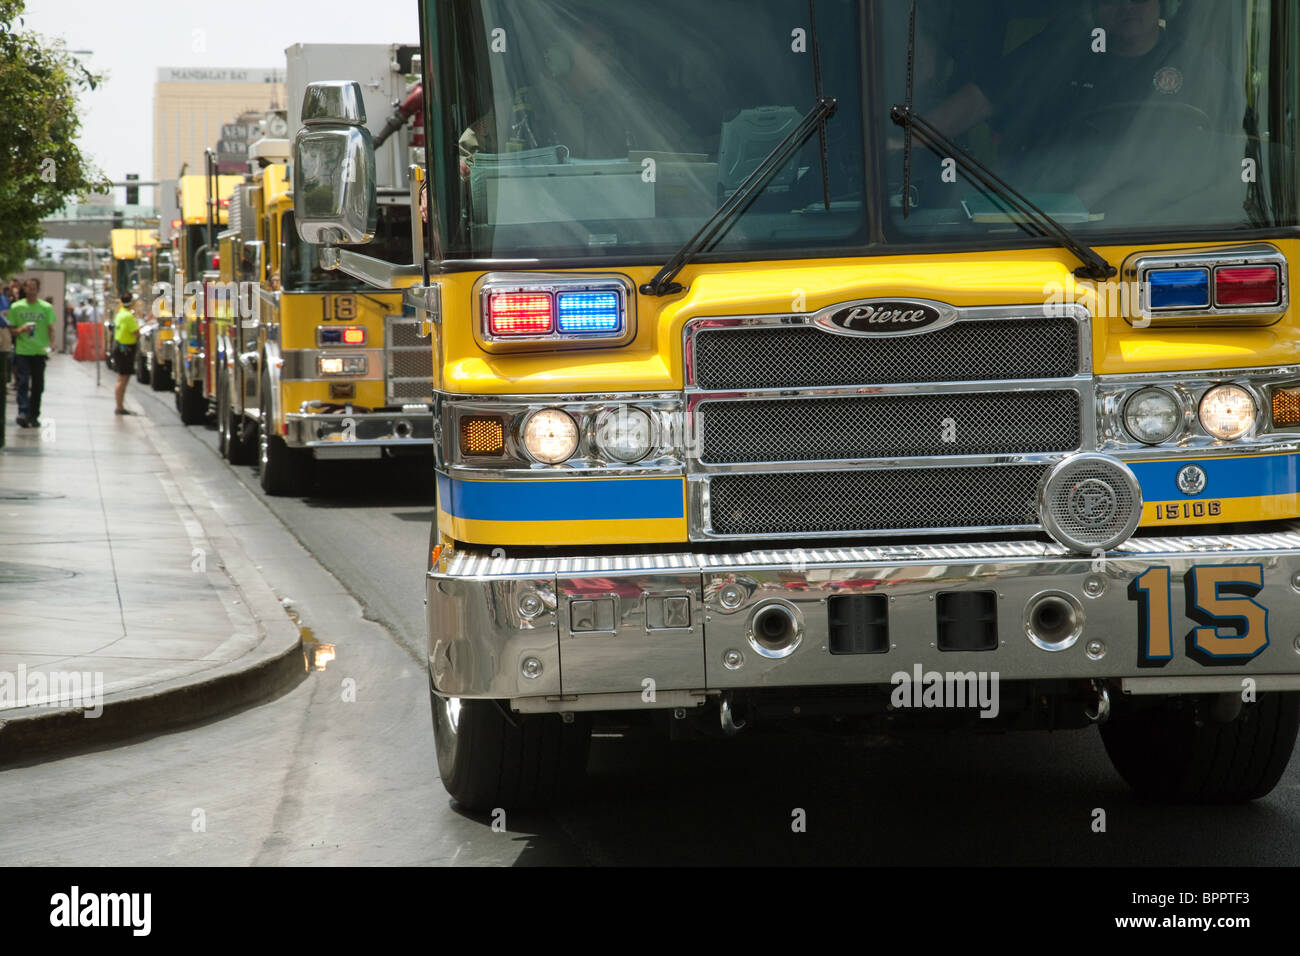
[{"xmin": 438, "ymin": 0, "xmax": 866, "ymax": 258}]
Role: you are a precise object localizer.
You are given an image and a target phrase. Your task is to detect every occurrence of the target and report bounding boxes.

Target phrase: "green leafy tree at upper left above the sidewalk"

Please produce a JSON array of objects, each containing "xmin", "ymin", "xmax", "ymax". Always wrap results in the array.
[{"xmin": 0, "ymin": 0, "xmax": 108, "ymax": 276}]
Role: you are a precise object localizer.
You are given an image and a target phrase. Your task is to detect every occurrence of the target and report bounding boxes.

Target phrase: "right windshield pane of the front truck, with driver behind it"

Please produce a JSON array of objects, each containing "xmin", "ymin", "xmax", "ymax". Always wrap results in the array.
[{"xmin": 878, "ymin": 0, "xmax": 1296, "ymax": 241}]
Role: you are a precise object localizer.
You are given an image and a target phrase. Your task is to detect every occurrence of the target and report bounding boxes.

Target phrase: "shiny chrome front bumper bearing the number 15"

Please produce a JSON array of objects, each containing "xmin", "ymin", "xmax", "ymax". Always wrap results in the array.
[{"xmin": 425, "ymin": 523, "xmax": 1300, "ymax": 710}]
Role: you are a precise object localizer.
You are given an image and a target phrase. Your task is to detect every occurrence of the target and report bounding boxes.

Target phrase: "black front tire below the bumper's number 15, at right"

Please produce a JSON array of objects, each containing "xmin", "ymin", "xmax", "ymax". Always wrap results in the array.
[{"xmin": 1101, "ymin": 691, "xmax": 1300, "ymax": 804}]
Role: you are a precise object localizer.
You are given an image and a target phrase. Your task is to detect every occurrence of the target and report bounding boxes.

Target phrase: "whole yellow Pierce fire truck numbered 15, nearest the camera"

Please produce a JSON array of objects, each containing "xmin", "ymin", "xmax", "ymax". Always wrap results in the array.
[{"xmin": 294, "ymin": 0, "xmax": 1300, "ymax": 809}]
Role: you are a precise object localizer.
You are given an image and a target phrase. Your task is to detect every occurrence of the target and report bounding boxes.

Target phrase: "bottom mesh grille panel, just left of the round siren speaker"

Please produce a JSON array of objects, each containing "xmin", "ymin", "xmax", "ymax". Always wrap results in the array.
[{"xmin": 709, "ymin": 464, "xmax": 1048, "ymax": 536}]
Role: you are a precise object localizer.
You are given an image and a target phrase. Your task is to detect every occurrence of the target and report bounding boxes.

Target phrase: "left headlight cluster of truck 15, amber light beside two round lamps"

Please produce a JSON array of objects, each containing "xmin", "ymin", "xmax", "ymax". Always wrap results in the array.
[{"xmin": 456, "ymin": 405, "xmax": 662, "ymax": 464}]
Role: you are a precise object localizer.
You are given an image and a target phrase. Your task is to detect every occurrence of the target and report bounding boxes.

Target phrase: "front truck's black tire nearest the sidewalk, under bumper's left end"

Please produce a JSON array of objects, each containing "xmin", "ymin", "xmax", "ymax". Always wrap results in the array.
[{"xmin": 429, "ymin": 689, "xmax": 592, "ymax": 813}]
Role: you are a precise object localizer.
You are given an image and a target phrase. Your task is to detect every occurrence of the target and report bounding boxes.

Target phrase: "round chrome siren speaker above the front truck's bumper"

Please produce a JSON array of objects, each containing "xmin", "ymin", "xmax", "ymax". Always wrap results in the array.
[{"xmin": 1039, "ymin": 451, "xmax": 1141, "ymax": 554}]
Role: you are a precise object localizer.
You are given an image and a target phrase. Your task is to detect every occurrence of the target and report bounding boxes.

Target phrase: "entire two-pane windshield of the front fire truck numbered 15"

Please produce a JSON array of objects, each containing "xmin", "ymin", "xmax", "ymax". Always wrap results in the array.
[{"xmin": 428, "ymin": 0, "xmax": 1300, "ymax": 261}]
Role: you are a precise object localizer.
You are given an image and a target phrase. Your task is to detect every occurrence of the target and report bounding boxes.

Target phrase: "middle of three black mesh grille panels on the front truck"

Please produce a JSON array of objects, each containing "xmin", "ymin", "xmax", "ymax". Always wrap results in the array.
[{"xmin": 698, "ymin": 389, "xmax": 1080, "ymax": 464}]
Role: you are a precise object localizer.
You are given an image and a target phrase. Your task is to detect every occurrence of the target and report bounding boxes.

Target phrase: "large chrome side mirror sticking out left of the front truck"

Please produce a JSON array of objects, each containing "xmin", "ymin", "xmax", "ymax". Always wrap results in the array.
[{"xmin": 294, "ymin": 81, "xmax": 380, "ymax": 245}]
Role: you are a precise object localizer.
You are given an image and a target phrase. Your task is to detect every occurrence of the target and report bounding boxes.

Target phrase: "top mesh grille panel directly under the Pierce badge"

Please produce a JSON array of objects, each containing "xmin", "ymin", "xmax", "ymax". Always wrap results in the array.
[{"xmin": 690, "ymin": 316, "xmax": 1084, "ymax": 389}]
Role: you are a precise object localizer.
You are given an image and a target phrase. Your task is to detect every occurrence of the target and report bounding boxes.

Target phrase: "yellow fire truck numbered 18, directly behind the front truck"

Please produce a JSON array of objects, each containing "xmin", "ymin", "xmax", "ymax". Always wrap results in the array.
[{"xmin": 215, "ymin": 44, "xmax": 433, "ymax": 494}]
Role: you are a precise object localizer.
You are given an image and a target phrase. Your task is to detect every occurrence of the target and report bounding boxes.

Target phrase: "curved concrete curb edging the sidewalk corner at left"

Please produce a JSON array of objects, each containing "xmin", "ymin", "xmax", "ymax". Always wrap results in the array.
[{"xmin": 0, "ymin": 361, "xmax": 307, "ymax": 766}]
